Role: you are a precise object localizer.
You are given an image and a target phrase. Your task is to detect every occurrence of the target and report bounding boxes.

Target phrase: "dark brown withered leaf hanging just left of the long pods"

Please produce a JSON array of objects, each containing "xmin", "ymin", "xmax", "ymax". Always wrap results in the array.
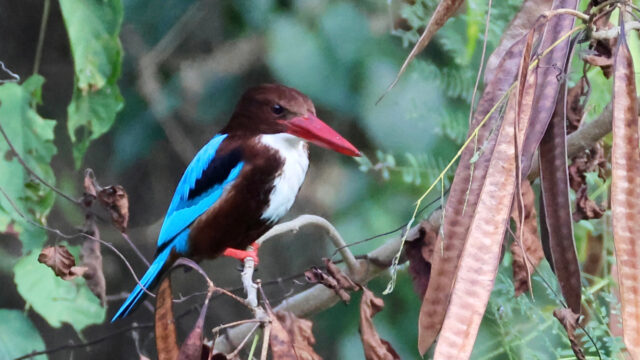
[{"xmin": 404, "ymin": 219, "xmax": 440, "ymax": 297}]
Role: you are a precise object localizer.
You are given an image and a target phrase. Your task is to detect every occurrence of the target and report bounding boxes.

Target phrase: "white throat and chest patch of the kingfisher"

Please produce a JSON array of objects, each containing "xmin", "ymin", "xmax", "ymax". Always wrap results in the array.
[{"xmin": 260, "ymin": 134, "xmax": 309, "ymax": 223}]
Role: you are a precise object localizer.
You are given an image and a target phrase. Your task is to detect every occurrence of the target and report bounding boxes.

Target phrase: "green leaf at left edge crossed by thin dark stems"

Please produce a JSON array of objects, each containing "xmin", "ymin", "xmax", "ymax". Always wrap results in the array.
[{"xmin": 0, "ymin": 75, "xmax": 56, "ymax": 253}]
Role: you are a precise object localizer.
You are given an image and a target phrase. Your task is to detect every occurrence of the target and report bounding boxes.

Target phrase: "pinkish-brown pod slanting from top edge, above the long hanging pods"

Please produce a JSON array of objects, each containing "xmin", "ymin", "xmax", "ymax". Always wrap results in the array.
[{"xmin": 484, "ymin": 0, "xmax": 553, "ymax": 84}]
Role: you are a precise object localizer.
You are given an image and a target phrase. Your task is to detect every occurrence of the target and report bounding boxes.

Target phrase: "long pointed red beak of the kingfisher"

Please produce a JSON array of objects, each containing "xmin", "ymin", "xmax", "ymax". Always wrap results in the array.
[{"xmin": 286, "ymin": 113, "xmax": 362, "ymax": 156}]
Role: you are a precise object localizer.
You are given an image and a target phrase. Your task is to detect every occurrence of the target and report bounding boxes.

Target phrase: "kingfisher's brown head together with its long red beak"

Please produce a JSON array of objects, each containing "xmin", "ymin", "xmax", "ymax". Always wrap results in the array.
[{"xmin": 222, "ymin": 84, "xmax": 360, "ymax": 156}]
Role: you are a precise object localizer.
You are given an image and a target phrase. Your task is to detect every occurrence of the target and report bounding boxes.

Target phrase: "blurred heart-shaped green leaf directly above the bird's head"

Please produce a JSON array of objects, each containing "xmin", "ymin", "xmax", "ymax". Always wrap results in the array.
[{"xmin": 267, "ymin": 3, "xmax": 370, "ymax": 113}]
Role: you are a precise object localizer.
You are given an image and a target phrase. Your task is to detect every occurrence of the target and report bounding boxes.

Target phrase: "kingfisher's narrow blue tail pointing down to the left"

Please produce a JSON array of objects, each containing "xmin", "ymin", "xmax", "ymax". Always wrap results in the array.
[{"xmin": 111, "ymin": 229, "xmax": 189, "ymax": 322}]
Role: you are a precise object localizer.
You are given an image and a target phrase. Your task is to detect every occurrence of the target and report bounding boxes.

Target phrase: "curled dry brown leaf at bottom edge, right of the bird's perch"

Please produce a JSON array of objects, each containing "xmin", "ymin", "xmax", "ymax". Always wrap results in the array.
[{"xmin": 360, "ymin": 287, "xmax": 400, "ymax": 360}]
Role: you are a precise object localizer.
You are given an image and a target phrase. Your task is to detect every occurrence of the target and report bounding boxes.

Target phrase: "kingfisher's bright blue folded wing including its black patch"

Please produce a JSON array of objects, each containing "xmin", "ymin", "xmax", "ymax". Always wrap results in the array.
[{"xmin": 158, "ymin": 134, "xmax": 244, "ymax": 253}]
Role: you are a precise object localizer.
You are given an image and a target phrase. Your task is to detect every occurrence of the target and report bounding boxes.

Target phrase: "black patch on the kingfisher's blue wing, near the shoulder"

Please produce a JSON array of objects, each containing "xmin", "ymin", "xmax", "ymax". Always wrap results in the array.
[{"xmin": 187, "ymin": 148, "xmax": 242, "ymax": 200}]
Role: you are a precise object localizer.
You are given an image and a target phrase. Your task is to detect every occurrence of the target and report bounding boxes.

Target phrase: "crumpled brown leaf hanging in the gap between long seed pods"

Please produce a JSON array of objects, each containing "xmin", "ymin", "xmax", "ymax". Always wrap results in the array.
[{"xmin": 511, "ymin": 180, "xmax": 544, "ymax": 297}]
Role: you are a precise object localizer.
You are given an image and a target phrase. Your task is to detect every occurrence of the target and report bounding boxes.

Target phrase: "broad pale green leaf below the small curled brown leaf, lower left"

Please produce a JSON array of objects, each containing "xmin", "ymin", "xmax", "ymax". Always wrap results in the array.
[{"xmin": 13, "ymin": 246, "xmax": 106, "ymax": 332}]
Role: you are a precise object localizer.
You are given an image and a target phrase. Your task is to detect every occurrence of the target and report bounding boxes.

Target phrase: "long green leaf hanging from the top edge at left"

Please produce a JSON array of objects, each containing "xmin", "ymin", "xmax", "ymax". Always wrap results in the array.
[{"xmin": 60, "ymin": 0, "xmax": 123, "ymax": 167}]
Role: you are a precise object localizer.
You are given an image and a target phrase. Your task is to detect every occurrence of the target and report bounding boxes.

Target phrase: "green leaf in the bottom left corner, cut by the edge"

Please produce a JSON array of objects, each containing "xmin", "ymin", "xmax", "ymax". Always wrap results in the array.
[{"xmin": 0, "ymin": 309, "xmax": 47, "ymax": 360}]
